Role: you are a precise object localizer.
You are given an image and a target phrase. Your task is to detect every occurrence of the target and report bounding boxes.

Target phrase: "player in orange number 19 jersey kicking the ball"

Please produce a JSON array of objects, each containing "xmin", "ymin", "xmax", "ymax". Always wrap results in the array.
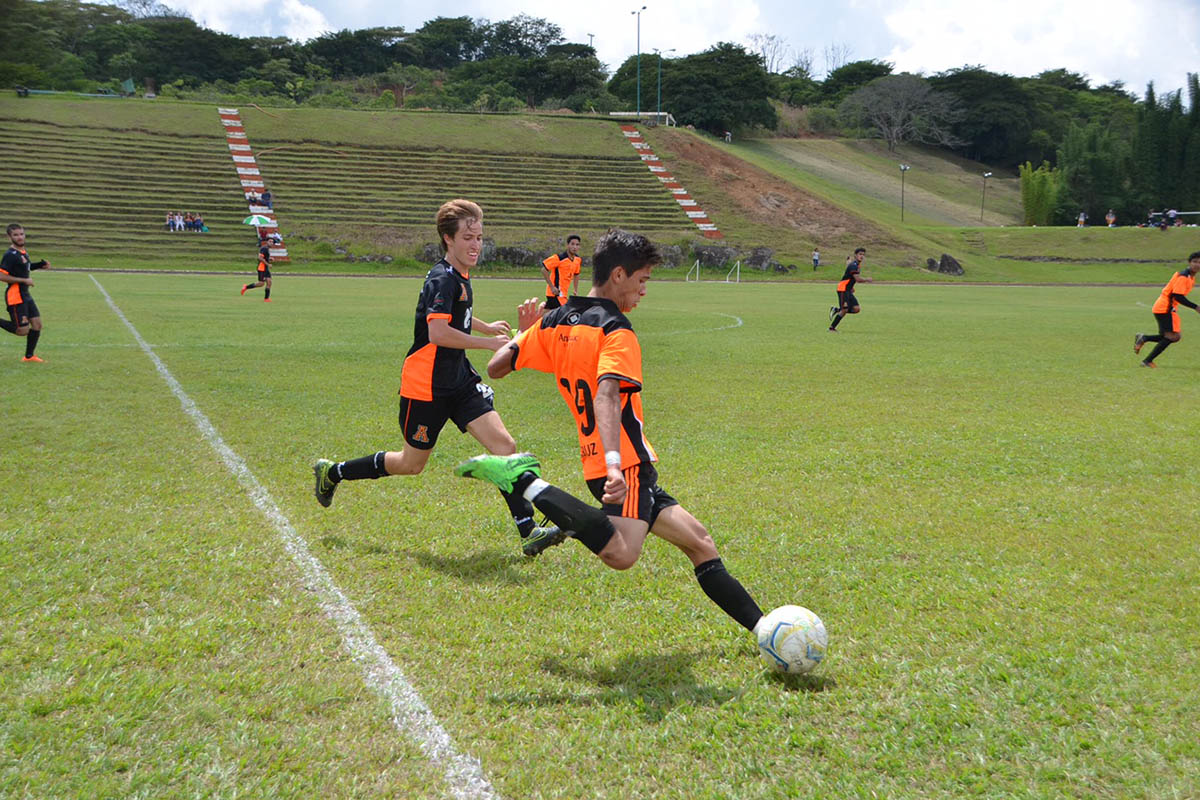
[{"xmin": 455, "ymin": 230, "xmax": 762, "ymax": 631}]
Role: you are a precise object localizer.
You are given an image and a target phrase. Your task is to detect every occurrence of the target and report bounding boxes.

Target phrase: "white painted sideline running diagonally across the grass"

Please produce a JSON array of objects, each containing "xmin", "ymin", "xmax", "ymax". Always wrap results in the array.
[{"xmin": 88, "ymin": 275, "xmax": 499, "ymax": 798}]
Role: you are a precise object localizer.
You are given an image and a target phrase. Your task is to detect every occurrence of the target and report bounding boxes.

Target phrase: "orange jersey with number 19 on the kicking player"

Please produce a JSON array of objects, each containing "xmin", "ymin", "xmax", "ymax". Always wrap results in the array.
[{"xmin": 512, "ymin": 295, "xmax": 659, "ymax": 479}]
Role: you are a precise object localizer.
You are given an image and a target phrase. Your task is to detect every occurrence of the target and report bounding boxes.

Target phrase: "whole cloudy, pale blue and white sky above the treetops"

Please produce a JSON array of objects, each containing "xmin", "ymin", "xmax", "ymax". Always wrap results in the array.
[{"xmin": 184, "ymin": 0, "xmax": 1200, "ymax": 95}]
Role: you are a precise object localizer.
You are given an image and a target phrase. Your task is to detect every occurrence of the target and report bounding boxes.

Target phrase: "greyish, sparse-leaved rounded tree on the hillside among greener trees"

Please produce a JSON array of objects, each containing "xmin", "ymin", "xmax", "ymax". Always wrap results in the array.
[{"xmin": 838, "ymin": 74, "xmax": 962, "ymax": 152}]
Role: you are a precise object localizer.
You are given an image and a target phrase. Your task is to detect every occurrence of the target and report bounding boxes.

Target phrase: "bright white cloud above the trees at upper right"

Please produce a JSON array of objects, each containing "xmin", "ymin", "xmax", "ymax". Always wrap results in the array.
[{"xmin": 884, "ymin": 0, "xmax": 1200, "ymax": 94}]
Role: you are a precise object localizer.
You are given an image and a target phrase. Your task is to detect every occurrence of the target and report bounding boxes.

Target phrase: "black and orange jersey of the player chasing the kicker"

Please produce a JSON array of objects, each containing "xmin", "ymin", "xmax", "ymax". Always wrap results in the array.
[{"xmin": 400, "ymin": 259, "xmax": 479, "ymax": 401}]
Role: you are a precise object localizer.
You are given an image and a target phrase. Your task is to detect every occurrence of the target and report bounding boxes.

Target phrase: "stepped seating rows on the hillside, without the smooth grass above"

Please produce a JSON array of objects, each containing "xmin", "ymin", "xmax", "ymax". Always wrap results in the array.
[{"xmin": 0, "ymin": 116, "xmax": 694, "ymax": 267}]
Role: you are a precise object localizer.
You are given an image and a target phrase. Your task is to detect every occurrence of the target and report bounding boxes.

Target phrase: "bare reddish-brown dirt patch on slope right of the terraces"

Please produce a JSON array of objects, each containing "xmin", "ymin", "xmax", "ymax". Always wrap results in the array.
[{"xmin": 654, "ymin": 128, "xmax": 904, "ymax": 247}]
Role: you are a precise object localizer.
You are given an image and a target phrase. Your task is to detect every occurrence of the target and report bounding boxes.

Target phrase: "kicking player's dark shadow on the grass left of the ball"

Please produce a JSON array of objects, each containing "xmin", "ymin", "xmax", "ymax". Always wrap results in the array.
[{"xmin": 493, "ymin": 652, "xmax": 742, "ymax": 722}]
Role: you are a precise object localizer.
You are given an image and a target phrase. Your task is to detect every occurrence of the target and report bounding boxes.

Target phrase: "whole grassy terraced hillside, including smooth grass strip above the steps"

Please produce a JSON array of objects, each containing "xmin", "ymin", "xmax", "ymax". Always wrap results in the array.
[{"xmin": 0, "ymin": 98, "xmax": 695, "ymax": 267}]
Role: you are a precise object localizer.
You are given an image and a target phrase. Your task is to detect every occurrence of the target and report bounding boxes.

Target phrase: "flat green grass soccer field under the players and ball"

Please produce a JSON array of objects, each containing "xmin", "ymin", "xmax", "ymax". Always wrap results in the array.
[{"xmin": 0, "ymin": 267, "xmax": 1200, "ymax": 799}]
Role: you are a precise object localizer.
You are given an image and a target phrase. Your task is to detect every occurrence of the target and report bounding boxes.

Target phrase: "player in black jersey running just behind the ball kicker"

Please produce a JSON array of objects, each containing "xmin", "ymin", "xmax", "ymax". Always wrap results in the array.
[{"xmin": 313, "ymin": 199, "xmax": 562, "ymax": 555}]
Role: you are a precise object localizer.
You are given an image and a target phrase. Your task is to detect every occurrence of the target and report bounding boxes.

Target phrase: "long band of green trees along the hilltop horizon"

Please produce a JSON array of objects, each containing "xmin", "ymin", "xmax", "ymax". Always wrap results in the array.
[{"xmin": 0, "ymin": 0, "xmax": 1200, "ymax": 224}]
